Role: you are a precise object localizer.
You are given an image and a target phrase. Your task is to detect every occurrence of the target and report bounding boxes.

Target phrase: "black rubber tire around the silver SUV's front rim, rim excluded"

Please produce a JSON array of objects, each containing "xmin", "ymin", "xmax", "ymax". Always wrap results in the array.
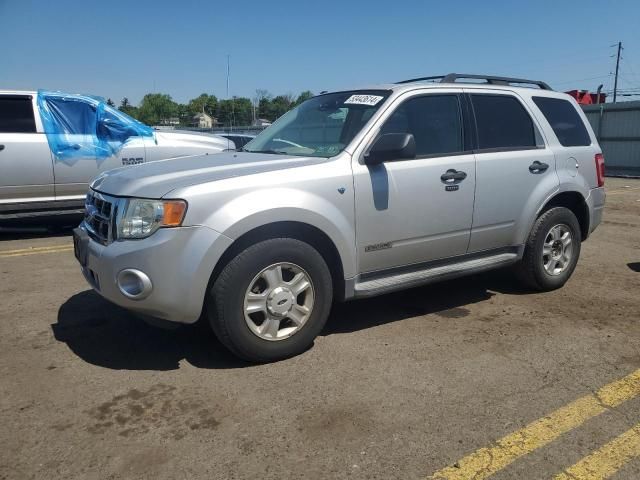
[{"xmin": 205, "ymin": 238, "xmax": 333, "ymax": 363}]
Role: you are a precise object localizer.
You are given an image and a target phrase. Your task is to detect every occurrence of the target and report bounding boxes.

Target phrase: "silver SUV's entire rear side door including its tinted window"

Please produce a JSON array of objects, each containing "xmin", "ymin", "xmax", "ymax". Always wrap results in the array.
[{"xmin": 469, "ymin": 89, "xmax": 558, "ymax": 253}]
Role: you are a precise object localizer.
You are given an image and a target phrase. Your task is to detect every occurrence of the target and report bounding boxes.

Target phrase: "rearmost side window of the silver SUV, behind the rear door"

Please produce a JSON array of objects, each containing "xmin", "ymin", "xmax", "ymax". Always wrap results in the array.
[{"xmin": 533, "ymin": 97, "xmax": 591, "ymax": 147}]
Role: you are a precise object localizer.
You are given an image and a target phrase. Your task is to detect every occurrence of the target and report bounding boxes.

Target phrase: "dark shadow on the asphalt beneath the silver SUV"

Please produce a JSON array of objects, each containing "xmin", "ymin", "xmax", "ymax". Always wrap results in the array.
[{"xmin": 51, "ymin": 272, "xmax": 529, "ymax": 371}]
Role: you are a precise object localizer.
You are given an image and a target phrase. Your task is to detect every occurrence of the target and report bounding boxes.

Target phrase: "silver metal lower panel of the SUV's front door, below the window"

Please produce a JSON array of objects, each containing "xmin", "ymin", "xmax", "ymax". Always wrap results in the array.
[{"xmin": 354, "ymin": 155, "xmax": 475, "ymax": 273}]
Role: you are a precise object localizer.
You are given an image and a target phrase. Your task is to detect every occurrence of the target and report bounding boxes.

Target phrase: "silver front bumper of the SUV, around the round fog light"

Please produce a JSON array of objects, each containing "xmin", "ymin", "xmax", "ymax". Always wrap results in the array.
[{"xmin": 77, "ymin": 226, "xmax": 232, "ymax": 323}]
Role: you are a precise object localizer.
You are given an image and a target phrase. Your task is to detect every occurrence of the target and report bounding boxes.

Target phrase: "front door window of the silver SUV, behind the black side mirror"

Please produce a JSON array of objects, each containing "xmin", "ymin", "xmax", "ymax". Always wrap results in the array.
[{"xmin": 380, "ymin": 95, "xmax": 464, "ymax": 157}]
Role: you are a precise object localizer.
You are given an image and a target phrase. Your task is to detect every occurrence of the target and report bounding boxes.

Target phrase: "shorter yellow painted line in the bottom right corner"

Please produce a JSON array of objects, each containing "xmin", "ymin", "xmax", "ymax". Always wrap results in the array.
[{"xmin": 554, "ymin": 424, "xmax": 640, "ymax": 480}]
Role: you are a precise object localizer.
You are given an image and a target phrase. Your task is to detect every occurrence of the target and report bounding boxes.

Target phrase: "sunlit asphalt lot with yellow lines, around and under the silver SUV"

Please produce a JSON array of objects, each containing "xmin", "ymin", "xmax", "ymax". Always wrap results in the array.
[{"xmin": 0, "ymin": 178, "xmax": 640, "ymax": 480}]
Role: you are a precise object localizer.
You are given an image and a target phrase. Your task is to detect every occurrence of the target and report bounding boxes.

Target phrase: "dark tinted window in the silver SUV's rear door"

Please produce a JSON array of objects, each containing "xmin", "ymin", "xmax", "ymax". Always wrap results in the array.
[{"xmin": 471, "ymin": 94, "xmax": 536, "ymax": 150}]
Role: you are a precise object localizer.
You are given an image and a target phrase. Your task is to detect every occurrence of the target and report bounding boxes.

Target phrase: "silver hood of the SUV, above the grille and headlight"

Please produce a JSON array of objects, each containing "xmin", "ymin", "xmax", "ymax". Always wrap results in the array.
[{"xmin": 91, "ymin": 152, "xmax": 327, "ymax": 198}]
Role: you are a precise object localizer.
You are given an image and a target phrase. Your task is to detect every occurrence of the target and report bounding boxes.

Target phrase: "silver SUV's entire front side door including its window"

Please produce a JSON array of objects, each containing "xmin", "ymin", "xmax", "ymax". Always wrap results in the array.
[{"xmin": 353, "ymin": 92, "xmax": 475, "ymax": 273}]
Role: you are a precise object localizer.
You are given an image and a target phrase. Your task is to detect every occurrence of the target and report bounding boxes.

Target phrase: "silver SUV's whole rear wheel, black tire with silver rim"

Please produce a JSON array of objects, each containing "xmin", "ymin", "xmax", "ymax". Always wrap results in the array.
[{"xmin": 517, "ymin": 207, "xmax": 582, "ymax": 291}]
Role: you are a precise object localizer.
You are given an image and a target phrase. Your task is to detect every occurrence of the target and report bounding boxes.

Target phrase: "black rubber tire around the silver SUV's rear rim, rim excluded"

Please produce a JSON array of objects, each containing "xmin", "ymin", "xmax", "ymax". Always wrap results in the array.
[{"xmin": 516, "ymin": 207, "xmax": 582, "ymax": 292}]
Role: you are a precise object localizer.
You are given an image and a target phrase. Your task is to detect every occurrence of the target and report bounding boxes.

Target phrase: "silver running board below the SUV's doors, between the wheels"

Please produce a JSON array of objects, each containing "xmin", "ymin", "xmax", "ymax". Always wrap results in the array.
[{"xmin": 354, "ymin": 253, "xmax": 520, "ymax": 298}]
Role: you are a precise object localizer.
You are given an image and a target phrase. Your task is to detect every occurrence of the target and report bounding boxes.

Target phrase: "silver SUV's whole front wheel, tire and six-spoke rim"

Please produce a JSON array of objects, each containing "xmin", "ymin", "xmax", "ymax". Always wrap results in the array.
[{"xmin": 207, "ymin": 238, "xmax": 333, "ymax": 362}]
